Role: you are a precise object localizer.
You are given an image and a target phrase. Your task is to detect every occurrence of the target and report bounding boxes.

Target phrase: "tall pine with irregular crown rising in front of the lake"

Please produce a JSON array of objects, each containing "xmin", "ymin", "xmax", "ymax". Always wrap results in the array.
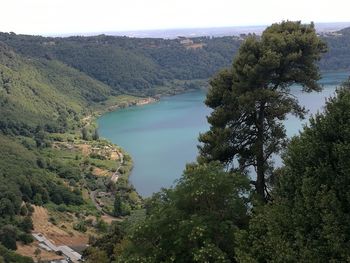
[{"xmin": 199, "ymin": 21, "xmax": 326, "ymax": 199}]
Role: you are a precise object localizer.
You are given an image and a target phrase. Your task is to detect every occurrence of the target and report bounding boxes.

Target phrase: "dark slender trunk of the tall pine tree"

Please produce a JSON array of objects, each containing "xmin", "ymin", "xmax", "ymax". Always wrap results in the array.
[{"xmin": 255, "ymin": 102, "xmax": 266, "ymax": 201}]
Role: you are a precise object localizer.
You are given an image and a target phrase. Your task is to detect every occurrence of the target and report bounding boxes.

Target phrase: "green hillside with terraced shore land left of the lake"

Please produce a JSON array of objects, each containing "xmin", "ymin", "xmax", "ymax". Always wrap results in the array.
[{"xmin": 0, "ymin": 40, "xmax": 140, "ymax": 262}]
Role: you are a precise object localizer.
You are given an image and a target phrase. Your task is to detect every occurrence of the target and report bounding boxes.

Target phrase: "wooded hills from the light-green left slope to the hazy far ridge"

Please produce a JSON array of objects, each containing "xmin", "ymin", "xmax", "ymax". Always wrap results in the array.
[{"xmin": 0, "ymin": 28, "xmax": 350, "ymax": 134}]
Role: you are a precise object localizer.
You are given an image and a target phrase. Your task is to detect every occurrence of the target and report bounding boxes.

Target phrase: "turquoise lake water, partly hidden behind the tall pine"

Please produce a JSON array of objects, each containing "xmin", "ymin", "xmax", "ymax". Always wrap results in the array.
[{"xmin": 98, "ymin": 72, "xmax": 350, "ymax": 196}]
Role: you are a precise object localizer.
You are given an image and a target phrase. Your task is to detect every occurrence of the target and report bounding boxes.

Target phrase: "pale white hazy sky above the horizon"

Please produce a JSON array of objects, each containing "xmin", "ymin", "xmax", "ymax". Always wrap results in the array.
[{"xmin": 0, "ymin": 0, "xmax": 350, "ymax": 34}]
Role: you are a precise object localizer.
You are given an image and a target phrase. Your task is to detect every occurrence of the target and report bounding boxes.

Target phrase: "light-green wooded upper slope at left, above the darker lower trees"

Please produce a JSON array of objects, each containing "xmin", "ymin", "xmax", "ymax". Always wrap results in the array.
[{"xmin": 0, "ymin": 44, "xmax": 111, "ymax": 134}]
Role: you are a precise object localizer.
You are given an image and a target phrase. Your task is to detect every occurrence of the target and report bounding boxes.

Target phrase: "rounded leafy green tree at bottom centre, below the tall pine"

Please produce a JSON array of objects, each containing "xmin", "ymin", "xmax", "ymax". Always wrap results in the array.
[{"xmin": 106, "ymin": 163, "xmax": 250, "ymax": 263}]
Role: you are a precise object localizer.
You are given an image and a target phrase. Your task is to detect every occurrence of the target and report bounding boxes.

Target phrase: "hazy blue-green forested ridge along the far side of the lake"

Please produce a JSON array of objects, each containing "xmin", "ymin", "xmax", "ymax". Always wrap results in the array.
[{"xmin": 0, "ymin": 25, "xmax": 350, "ymax": 96}]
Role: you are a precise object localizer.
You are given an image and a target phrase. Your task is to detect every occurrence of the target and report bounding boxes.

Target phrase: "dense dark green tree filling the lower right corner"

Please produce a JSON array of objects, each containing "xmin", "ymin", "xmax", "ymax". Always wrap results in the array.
[{"xmin": 237, "ymin": 82, "xmax": 350, "ymax": 262}]
